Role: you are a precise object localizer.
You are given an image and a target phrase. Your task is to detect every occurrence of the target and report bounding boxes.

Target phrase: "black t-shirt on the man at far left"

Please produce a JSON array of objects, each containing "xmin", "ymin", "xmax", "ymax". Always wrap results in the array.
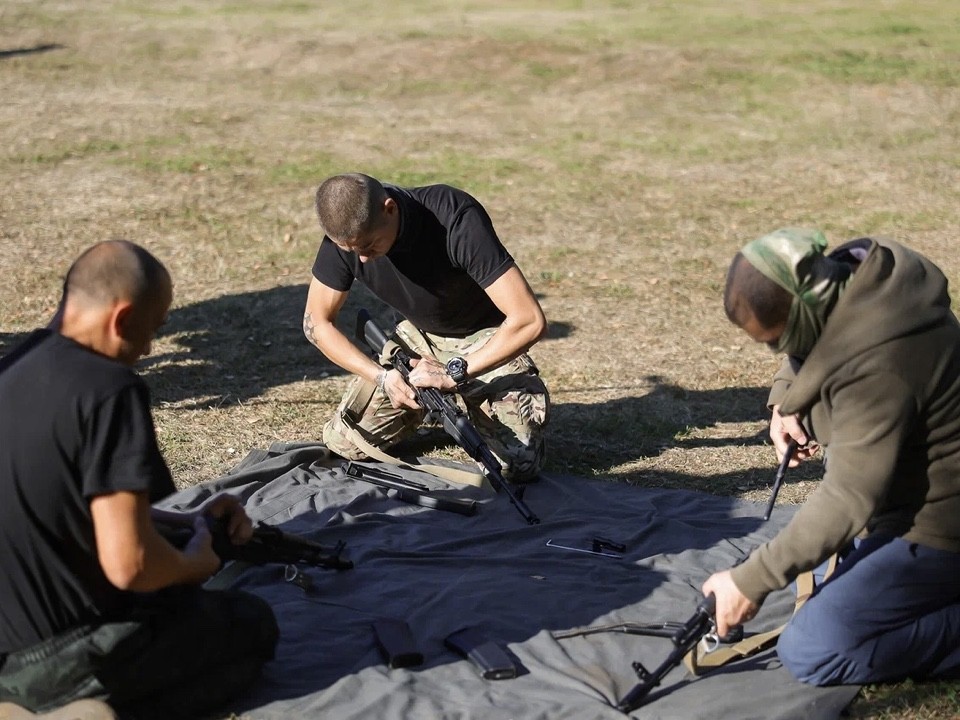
[{"xmin": 0, "ymin": 330, "xmax": 175, "ymax": 653}]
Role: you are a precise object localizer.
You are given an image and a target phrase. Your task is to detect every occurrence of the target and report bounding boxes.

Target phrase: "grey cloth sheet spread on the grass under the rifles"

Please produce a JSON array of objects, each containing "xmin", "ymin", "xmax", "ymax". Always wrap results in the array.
[{"xmin": 154, "ymin": 444, "xmax": 858, "ymax": 720}]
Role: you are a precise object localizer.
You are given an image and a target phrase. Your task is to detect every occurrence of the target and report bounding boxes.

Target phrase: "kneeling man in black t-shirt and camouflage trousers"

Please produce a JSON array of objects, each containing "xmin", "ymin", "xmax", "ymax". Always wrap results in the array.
[{"xmin": 303, "ymin": 173, "xmax": 549, "ymax": 482}]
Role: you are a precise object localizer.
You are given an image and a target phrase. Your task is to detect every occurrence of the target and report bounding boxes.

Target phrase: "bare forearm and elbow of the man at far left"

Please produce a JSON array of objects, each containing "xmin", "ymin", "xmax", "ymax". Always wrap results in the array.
[{"xmin": 90, "ymin": 491, "xmax": 220, "ymax": 592}]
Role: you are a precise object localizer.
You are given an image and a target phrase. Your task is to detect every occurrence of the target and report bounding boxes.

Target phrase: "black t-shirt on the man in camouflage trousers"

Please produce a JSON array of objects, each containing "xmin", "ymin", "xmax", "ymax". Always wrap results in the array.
[{"xmin": 313, "ymin": 185, "xmax": 513, "ymax": 337}]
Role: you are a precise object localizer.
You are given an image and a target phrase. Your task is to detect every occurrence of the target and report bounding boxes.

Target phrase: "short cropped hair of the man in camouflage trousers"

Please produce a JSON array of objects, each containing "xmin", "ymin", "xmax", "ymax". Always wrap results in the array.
[{"xmin": 315, "ymin": 173, "xmax": 387, "ymax": 243}]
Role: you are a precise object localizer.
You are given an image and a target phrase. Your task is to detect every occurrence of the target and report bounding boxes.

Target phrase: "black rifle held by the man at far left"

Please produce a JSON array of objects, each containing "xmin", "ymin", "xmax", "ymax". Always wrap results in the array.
[{"xmin": 150, "ymin": 508, "xmax": 353, "ymax": 570}]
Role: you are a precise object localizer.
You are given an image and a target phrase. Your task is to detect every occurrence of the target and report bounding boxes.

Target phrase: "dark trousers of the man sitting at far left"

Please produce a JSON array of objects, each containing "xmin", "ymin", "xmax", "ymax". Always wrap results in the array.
[{"xmin": 0, "ymin": 587, "xmax": 278, "ymax": 719}]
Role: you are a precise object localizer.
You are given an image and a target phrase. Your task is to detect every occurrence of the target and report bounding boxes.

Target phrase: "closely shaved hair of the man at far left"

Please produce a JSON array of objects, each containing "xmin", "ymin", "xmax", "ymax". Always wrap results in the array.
[{"xmin": 63, "ymin": 240, "xmax": 170, "ymax": 307}]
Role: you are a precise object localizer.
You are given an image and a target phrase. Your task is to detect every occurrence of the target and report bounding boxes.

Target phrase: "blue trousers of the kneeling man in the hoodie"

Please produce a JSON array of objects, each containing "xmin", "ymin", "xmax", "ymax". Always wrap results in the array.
[{"xmin": 777, "ymin": 536, "xmax": 960, "ymax": 685}]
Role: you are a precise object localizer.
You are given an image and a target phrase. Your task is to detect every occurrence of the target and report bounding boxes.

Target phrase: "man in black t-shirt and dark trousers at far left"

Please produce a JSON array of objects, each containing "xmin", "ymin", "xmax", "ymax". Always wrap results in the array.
[{"xmin": 0, "ymin": 241, "xmax": 277, "ymax": 718}]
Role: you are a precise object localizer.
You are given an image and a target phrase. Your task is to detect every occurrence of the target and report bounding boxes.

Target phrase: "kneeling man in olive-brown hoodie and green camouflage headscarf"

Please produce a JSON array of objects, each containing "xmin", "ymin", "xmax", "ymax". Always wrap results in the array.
[{"xmin": 703, "ymin": 228, "xmax": 960, "ymax": 685}]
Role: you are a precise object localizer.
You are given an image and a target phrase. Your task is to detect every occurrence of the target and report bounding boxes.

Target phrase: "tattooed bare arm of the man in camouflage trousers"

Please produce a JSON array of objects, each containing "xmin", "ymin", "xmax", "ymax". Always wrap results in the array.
[{"xmin": 303, "ymin": 278, "xmax": 418, "ymax": 408}]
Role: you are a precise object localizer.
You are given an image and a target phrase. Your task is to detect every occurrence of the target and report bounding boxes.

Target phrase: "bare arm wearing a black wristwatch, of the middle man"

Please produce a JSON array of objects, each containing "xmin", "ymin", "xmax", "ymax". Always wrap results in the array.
[{"xmin": 410, "ymin": 266, "xmax": 547, "ymax": 389}]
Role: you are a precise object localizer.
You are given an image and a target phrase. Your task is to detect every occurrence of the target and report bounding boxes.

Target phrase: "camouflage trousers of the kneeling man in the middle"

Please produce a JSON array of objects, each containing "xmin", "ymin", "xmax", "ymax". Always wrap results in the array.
[{"xmin": 323, "ymin": 320, "xmax": 550, "ymax": 482}]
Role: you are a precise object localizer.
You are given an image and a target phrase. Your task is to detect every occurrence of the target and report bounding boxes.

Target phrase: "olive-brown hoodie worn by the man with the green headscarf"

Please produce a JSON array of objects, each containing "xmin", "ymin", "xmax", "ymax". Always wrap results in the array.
[{"xmin": 733, "ymin": 239, "xmax": 960, "ymax": 602}]
